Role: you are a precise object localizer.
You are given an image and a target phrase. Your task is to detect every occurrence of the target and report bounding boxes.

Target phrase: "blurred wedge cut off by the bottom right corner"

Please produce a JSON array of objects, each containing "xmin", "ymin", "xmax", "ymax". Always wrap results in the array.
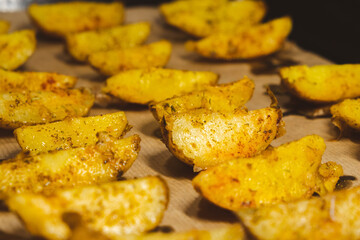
[{"xmin": 236, "ymin": 187, "xmax": 360, "ymax": 240}]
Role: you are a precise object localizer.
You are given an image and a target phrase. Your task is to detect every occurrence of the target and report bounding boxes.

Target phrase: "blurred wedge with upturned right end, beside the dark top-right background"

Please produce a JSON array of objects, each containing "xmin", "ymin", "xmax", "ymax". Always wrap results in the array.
[{"xmin": 186, "ymin": 17, "xmax": 292, "ymax": 60}]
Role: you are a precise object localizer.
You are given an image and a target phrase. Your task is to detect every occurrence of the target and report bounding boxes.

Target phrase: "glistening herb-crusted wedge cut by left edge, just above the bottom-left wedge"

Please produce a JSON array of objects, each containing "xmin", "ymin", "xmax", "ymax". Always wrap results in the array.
[{"xmin": 0, "ymin": 133, "xmax": 140, "ymax": 198}]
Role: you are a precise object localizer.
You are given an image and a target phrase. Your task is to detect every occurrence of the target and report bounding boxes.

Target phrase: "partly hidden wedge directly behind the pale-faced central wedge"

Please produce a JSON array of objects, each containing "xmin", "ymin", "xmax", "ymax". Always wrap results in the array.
[{"xmin": 149, "ymin": 77, "xmax": 255, "ymax": 122}]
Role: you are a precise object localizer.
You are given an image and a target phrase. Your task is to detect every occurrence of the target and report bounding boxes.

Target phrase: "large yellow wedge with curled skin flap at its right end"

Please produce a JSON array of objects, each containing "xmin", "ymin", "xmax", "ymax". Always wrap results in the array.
[{"xmin": 193, "ymin": 135, "xmax": 343, "ymax": 211}]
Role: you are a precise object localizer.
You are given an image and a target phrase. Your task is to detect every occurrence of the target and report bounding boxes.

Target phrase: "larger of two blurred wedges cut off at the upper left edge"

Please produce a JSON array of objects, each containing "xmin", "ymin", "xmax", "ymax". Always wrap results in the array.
[{"xmin": 0, "ymin": 30, "xmax": 36, "ymax": 70}]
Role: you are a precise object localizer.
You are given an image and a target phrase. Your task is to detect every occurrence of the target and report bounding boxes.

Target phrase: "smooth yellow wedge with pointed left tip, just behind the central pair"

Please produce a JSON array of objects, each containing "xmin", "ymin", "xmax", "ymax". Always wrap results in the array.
[{"xmin": 102, "ymin": 68, "xmax": 219, "ymax": 104}]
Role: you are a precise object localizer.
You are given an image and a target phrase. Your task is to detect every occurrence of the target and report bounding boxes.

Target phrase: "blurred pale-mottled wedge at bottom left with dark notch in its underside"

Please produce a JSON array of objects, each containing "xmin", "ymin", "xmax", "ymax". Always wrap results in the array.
[{"xmin": 6, "ymin": 177, "xmax": 169, "ymax": 239}]
